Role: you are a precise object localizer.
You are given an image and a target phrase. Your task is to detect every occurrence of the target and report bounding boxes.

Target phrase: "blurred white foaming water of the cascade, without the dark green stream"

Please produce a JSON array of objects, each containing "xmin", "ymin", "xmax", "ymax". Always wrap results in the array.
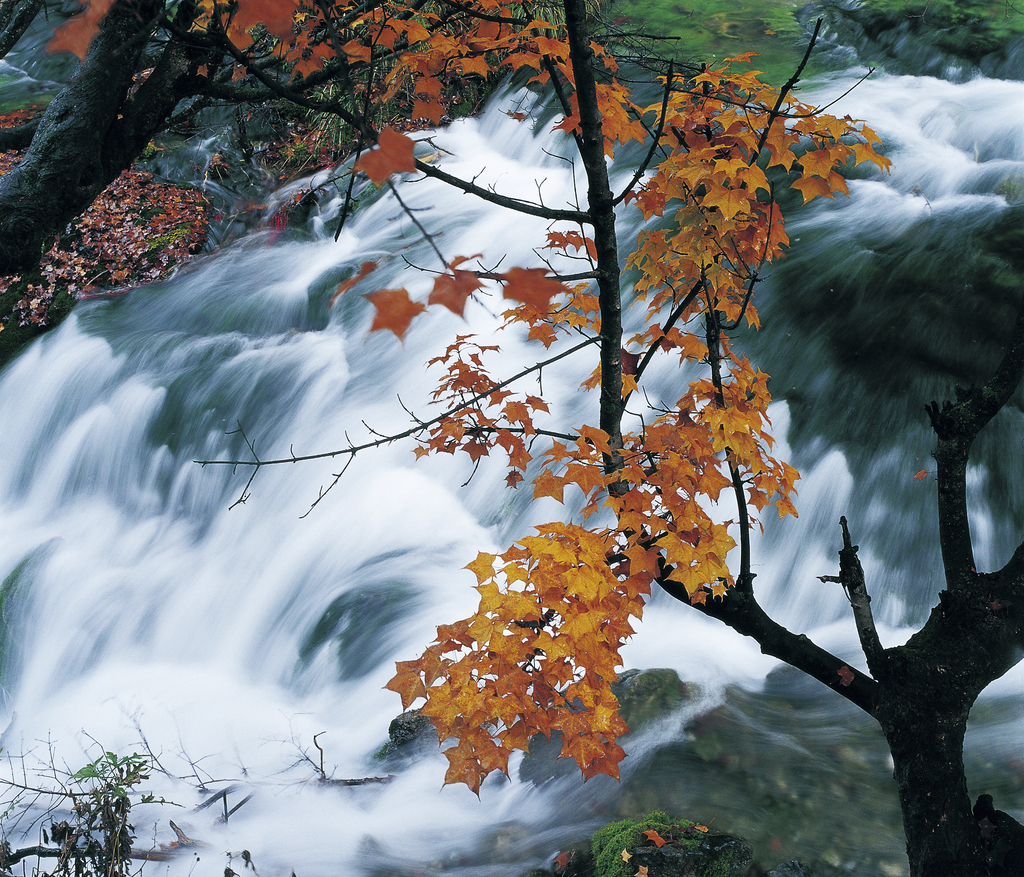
[{"xmin": 0, "ymin": 63, "xmax": 1024, "ymax": 877}]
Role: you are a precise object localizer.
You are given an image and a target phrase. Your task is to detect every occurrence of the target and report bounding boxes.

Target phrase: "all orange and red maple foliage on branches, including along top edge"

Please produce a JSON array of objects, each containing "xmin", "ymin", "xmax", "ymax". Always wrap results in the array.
[{"xmin": 48, "ymin": 0, "xmax": 888, "ymax": 791}]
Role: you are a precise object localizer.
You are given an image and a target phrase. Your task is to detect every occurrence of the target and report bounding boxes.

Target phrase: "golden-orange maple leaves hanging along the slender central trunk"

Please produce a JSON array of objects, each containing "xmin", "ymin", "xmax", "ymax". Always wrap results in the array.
[{"xmin": 368, "ymin": 53, "xmax": 887, "ymax": 791}]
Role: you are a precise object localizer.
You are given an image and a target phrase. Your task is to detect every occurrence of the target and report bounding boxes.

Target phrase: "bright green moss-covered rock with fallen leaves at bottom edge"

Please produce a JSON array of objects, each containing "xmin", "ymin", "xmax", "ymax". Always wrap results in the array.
[{"xmin": 591, "ymin": 810, "xmax": 754, "ymax": 877}]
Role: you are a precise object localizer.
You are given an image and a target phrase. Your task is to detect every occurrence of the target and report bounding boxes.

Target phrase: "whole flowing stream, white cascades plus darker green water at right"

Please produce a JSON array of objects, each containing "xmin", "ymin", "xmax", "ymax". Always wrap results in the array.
[{"xmin": 0, "ymin": 20, "xmax": 1024, "ymax": 877}]
